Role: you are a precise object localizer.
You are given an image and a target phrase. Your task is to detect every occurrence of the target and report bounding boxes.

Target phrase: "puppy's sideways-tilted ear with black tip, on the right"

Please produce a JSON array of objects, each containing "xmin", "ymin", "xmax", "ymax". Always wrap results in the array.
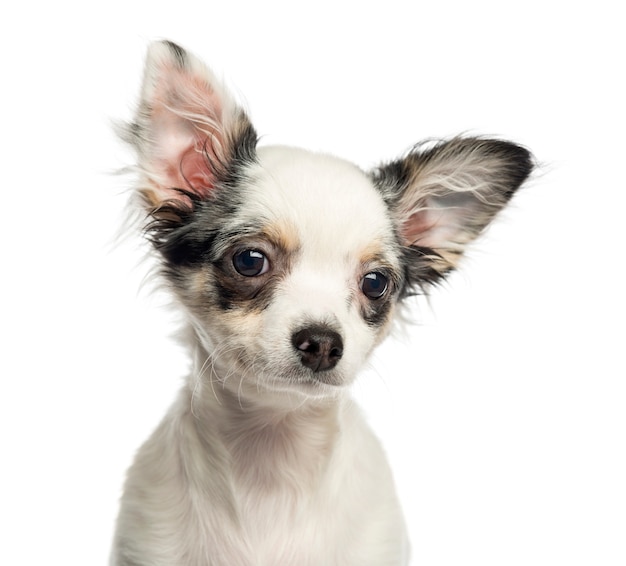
[{"xmin": 372, "ymin": 137, "xmax": 533, "ymax": 286}]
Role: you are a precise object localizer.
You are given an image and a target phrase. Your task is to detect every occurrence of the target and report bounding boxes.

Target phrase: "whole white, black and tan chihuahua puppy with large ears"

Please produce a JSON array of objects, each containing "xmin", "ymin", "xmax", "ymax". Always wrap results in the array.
[{"xmin": 111, "ymin": 42, "xmax": 532, "ymax": 566}]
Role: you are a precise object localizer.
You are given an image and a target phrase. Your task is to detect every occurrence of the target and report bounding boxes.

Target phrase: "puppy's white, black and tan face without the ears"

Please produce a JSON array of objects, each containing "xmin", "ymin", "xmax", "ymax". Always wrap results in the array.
[{"xmin": 146, "ymin": 142, "xmax": 404, "ymax": 396}]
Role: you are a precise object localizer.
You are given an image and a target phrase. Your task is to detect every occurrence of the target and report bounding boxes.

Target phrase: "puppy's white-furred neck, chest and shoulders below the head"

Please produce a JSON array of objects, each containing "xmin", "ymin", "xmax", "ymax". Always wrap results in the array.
[{"xmin": 113, "ymin": 391, "xmax": 407, "ymax": 566}]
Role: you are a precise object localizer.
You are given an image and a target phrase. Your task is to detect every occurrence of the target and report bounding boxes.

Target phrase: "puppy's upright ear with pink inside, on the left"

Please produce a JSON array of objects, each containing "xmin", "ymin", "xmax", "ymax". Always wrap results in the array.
[{"xmin": 125, "ymin": 41, "xmax": 257, "ymax": 215}]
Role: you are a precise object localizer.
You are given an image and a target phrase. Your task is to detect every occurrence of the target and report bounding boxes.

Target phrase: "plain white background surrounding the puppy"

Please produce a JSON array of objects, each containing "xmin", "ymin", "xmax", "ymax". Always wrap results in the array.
[{"xmin": 0, "ymin": 0, "xmax": 626, "ymax": 566}]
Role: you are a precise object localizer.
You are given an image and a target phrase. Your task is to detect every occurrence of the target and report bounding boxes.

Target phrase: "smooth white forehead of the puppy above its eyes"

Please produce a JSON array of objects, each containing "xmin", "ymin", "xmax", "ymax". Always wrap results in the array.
[{"xmin": 237, "ymin": 147, "xmax": 394, "ymax": 262}]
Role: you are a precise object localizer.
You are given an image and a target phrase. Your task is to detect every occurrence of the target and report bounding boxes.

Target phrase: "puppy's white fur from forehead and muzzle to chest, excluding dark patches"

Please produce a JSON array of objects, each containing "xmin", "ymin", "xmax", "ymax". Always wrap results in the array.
[{"xmin": 113, "ymin": 148, "xmax": 408, "ymax": 566}]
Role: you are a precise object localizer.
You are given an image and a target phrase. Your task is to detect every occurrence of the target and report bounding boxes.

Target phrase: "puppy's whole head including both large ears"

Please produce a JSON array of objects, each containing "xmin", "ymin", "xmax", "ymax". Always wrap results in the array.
[{"xmin": 127, "ymin": 42, "xmax": 531, "ymax": 397}]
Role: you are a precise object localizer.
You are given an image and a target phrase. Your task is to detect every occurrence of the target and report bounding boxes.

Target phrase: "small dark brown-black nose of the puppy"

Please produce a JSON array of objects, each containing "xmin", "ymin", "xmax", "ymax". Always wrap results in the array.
[{"xmin": 291, "ymin": 325, "xmax": 343, "ymax": 371}]
